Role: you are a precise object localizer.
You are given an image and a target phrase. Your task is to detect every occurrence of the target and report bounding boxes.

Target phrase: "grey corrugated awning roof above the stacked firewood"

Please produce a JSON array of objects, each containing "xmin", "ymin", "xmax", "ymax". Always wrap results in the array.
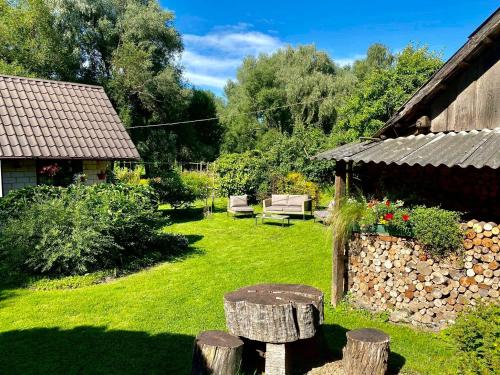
[{"xmin": 313, "ymin": 128, "xmax": 500, "ymax": 169}]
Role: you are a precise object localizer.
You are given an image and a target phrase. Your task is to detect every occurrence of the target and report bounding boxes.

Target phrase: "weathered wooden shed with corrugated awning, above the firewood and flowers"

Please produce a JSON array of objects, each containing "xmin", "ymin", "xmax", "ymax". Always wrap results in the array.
[{"xmin": 314, "ymin": 10, "xmax": 500, "ymax": 222}]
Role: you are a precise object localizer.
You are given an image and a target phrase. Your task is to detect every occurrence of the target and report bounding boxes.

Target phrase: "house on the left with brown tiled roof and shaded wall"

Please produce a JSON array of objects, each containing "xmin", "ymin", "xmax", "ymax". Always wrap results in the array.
[{"xmin": 0, "ymin": 75, "xmax": 139, "ymax": 197}]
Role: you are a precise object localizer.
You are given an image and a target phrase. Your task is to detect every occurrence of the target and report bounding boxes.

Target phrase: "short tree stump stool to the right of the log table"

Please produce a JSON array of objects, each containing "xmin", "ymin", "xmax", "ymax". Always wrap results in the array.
[{"xmin": 343, "ymin": 328, "xmax": 390, "ymax": 375}]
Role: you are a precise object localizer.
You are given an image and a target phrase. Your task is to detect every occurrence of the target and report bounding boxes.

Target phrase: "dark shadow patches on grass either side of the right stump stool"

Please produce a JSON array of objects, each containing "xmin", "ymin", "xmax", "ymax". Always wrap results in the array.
[{"xmin": 321, "ymin": 324, "xmax": 406, "ymax": 374}]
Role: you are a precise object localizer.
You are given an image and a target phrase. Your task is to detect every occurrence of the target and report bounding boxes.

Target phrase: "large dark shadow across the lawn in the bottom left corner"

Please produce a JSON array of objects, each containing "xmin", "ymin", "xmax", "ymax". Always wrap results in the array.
[{"xmin": 0, "ymin": 326, "xmax": 194, "ymax": 375}]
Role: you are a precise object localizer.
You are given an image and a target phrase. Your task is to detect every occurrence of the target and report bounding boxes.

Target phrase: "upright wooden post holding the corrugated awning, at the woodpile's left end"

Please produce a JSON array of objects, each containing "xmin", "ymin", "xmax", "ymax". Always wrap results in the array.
[{"xmin": 332, "ymin": 161, "xmax": 346, "ymax": 306}]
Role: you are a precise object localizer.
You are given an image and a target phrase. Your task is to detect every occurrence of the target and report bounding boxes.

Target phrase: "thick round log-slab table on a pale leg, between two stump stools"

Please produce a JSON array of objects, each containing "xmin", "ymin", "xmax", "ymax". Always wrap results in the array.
[{"xmin": 224, "ymin": 284, "xmax": 323, "ymax": 375}]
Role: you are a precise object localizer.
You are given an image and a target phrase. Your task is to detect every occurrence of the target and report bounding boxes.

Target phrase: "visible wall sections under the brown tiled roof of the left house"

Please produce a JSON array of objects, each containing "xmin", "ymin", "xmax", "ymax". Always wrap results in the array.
[{"xmin": 2, "ymin": 159, "xmax": 109, "ymax": 196}]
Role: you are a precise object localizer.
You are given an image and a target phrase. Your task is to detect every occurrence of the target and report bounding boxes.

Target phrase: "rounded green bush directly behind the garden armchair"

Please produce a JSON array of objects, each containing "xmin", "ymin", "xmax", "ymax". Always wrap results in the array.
[{"xmin": 213, "ymin": 151, "xmax": 269, "ymax": 199}]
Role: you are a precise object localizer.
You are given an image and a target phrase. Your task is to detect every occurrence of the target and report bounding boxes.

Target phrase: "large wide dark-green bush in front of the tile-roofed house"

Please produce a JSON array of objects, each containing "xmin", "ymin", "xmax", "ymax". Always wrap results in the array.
[{"xmin": 0, "ymin": 184, "xmax": 185, "ymax": 275}]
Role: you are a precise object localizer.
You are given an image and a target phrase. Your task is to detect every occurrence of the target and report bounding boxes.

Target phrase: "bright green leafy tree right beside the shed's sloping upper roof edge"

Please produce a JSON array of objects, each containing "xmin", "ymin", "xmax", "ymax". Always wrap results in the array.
[{"xmin": 331, "ymin": 45, "xmax": 442, "ymax": 145}]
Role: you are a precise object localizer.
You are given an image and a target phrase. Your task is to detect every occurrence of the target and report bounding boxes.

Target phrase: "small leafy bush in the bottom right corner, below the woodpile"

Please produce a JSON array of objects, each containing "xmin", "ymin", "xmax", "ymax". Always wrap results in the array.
[{"xmin": 448, "ymin": 303, "xmax": 500, "ymax": 375}]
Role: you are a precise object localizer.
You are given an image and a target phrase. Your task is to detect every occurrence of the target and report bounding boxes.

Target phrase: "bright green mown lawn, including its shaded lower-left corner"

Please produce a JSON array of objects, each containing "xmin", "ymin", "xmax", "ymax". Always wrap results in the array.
[{"xmin": 0, "ymin": 204, "xmax": 456, "ymax": 374}]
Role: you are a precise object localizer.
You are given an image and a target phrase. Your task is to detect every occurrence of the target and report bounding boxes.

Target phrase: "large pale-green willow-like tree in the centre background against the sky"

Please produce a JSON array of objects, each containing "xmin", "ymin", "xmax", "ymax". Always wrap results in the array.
[{"xmin": 219, "ymin": 46, "xmax": 355, "ymax": 152}]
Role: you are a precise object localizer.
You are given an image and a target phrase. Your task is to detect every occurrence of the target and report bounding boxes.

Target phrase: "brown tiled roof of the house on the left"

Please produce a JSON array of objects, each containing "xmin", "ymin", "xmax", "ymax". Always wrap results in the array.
[{"xmin": 0, "ymin": 75, "xmax": 139, "ymax": 160}]
